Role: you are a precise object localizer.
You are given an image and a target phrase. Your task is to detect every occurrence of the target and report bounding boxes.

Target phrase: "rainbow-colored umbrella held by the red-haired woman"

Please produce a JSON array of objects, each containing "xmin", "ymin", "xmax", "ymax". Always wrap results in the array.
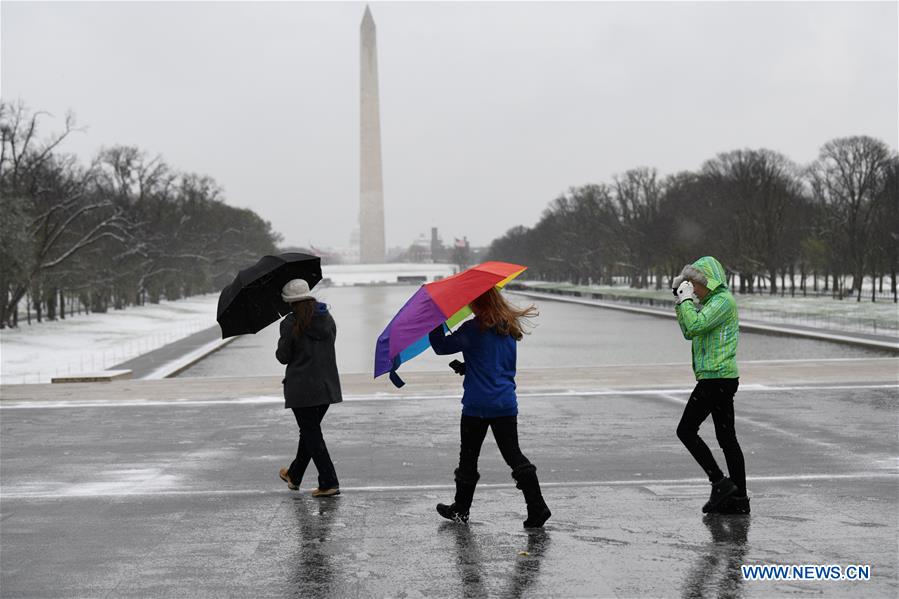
[{"xmin": 375, "ymin": 262, "xmax": 527, "ymax": 387}]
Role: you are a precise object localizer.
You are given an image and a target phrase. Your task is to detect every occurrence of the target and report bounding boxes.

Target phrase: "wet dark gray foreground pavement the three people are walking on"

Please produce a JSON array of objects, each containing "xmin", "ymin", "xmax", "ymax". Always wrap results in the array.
[{"xmin": 0, "ymin": 379, "xmax": 899, "ymax": 597}]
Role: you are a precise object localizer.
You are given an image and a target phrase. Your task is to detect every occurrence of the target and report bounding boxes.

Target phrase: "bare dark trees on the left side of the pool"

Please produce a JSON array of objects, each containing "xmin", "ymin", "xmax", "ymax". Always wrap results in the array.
[{"xmin": 0, "ymin": 102, "xmax": 280, "ymax": 328}]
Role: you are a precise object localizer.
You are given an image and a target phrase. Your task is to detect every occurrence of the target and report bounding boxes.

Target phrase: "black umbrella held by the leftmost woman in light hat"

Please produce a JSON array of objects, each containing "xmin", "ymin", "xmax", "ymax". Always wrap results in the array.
[{"xmin": 216, "ymin": 252, "xmax": 322, "ymax": 339}]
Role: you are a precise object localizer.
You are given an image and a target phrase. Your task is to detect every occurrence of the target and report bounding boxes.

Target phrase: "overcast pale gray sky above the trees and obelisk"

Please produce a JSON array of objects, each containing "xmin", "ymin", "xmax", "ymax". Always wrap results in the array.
[{"xmin": 0, "ymin": 0, "xmax": 899, "ymax": 246}]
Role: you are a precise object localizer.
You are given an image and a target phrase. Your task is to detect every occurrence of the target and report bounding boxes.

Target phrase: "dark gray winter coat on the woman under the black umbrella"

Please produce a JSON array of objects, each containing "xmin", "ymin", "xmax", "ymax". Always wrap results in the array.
[{"xmin": 275, "ymin": 303, "xmax": 343, "ymax": 408}]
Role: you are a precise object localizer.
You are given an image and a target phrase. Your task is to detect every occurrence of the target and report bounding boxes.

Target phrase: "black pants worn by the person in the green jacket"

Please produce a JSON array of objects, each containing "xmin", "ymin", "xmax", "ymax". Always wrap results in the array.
[{"xmin": 677, "ymin": 379, "xmax": 746, "ymax": 495}]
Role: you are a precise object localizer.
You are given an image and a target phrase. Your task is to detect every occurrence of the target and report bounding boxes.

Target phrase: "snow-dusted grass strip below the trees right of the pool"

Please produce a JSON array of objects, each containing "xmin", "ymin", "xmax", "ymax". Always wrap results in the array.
[{"xmin": 525, "ymin": 281, "xmax": 899, "ymax": 335}]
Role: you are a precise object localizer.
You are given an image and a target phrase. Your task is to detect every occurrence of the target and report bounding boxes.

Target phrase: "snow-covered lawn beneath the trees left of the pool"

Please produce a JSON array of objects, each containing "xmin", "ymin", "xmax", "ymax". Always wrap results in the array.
[{"xmin": 0, "ymin": 294, "xmax": 218, "ymax": 384}]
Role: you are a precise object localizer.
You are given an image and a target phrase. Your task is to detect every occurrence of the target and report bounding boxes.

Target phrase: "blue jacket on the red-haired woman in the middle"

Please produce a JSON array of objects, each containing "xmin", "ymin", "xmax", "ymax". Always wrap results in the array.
[{"xmin": 430, "ymin": 318, "xmax": 518, "ymax": 418}]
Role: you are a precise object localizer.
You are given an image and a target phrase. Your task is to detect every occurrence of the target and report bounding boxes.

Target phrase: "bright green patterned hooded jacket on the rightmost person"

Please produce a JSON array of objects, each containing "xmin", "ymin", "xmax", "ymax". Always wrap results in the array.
[{"xmin": 676, "ymin": 256, "xmax": 740, "ymax": 380}]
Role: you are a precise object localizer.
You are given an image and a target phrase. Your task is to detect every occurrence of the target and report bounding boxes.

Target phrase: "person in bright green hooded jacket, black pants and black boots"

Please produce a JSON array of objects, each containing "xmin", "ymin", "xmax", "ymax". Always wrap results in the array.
[{"xmin": 672, "ymin": 256, "xmax": 749, "ymax": 514}]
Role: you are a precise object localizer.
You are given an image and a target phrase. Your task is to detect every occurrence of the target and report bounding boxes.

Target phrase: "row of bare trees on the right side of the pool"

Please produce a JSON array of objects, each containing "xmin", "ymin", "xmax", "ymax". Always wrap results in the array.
[{"xmin": 490, "ymin": 136, "xmax": 899, "ymax": 301}]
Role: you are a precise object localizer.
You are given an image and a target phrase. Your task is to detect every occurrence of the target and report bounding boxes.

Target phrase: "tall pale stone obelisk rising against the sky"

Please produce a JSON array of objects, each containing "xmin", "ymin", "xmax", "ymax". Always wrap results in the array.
[{"xmin": 359, "ymin": 6, "xmax": 385, "ymax": 264}]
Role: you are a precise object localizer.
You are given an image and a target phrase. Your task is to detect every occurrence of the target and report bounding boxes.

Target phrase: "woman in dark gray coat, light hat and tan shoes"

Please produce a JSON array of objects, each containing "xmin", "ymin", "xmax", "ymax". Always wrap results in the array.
[{"xmin": 275, "ymin": 279, "xmax": 343, "ymax": 497}]
